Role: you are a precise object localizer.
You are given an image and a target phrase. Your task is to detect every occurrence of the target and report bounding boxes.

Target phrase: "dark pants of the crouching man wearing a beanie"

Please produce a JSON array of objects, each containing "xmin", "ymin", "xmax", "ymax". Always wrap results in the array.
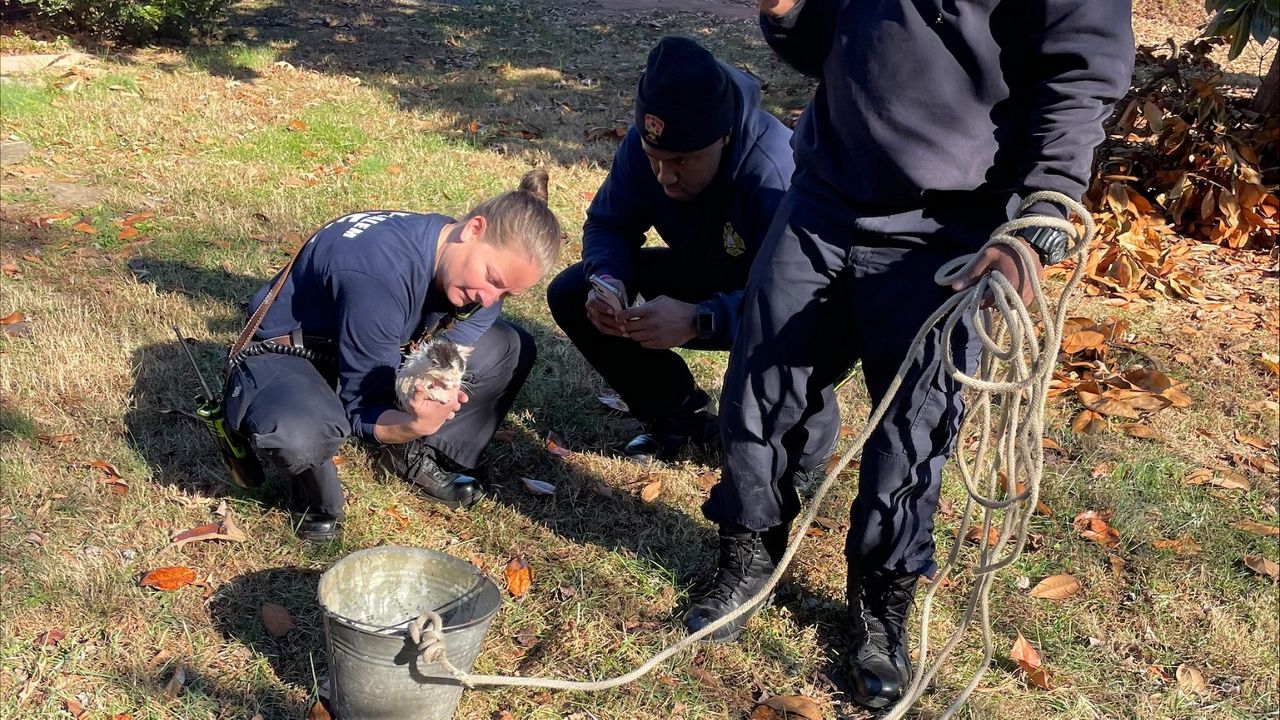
[{"xmin": 547, "ymin": 247, "xmax": 840, "ymax": 470}]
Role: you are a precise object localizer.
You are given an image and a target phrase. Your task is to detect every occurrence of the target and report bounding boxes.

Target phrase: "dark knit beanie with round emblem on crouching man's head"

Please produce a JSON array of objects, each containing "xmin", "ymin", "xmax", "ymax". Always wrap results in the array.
[{"xmin": 636, "ymin": 37, "xmax": 733, "ymax": 152}]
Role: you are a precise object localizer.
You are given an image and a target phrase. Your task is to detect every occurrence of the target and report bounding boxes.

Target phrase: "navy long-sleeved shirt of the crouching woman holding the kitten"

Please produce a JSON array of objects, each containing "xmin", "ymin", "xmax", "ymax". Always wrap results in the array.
[{"xmin": 252, "ymin": 210, "xmax": 502, "ymax": 441}]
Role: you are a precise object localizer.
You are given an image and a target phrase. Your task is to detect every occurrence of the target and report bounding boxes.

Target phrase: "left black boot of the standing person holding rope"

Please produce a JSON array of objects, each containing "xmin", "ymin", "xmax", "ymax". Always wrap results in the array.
[{"xmin": 685, "ymin": 525, "xmax": 787, "ymax": 643}]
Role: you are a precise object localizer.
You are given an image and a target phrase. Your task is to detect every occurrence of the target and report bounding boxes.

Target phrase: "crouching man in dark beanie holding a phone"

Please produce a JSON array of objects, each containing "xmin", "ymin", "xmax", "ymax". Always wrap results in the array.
[{"xmin": 547, "ymin": 37, "xmax": 838, "ymax": 469}]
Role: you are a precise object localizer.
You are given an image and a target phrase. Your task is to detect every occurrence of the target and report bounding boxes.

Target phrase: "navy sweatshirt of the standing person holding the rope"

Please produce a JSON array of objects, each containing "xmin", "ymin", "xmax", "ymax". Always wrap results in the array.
[{"xmin": 760, "ymin": 0, "xmax": 1134, "ymax": 217}]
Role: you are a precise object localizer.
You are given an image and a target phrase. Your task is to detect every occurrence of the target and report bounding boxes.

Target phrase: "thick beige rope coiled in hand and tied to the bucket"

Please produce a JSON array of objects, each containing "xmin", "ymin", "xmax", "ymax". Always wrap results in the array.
[{"xmin": 410, "ymin": 192, "xmax": 1094, "ymax": 707}]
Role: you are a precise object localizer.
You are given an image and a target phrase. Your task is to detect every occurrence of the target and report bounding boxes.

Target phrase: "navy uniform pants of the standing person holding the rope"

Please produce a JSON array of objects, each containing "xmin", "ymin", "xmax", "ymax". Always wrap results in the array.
[{"xmin": 703, "ymin": 187, "xmax": 1004, "ymax": 575}]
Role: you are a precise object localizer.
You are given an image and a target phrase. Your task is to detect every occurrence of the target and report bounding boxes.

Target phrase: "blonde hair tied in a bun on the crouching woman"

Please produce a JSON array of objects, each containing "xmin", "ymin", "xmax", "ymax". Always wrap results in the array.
[{"xmin": 462, "ymin": 168, "xmax": 564, "ymax": 273}]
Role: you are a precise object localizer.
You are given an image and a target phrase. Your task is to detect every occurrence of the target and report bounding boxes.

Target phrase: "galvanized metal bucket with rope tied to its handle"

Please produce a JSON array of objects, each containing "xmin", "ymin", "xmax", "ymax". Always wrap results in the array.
[{"xmin": 319, "ymin": 546, "xmax": 502, "ymax": 720}]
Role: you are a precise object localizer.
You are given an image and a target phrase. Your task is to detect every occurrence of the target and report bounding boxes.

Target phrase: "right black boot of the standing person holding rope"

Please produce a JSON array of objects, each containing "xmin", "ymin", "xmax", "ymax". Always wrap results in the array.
[{"xmin": 847, "ymin": 569, "xmax": 919, "ymax": 710}]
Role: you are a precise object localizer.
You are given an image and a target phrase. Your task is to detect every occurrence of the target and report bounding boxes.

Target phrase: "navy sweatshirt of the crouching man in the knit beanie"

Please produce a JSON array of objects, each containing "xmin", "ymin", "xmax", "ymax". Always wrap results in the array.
[{"xmin": 582, "ymin": 63, "xmax": 795, "ymax": 342}]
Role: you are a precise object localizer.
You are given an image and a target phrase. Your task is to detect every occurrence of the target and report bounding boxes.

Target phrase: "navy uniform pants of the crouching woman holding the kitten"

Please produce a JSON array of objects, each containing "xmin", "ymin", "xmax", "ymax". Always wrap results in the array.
[{"xmin": 227, "ymin": 320, "xmax": 535, "ymax": 518}]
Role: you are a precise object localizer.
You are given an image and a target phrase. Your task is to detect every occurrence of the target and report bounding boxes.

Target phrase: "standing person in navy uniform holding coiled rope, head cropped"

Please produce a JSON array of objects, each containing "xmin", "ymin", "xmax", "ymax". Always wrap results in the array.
[{"xmin": 686, "ymin": 0, "xmax": 1134, "ymax": 707}]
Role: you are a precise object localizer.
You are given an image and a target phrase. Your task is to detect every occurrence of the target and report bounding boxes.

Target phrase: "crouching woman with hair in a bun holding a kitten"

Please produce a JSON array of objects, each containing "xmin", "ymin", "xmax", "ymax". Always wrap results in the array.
[{"xmin": 227, "ymin": 170, "xmax": 562, "ymax": 541}]
